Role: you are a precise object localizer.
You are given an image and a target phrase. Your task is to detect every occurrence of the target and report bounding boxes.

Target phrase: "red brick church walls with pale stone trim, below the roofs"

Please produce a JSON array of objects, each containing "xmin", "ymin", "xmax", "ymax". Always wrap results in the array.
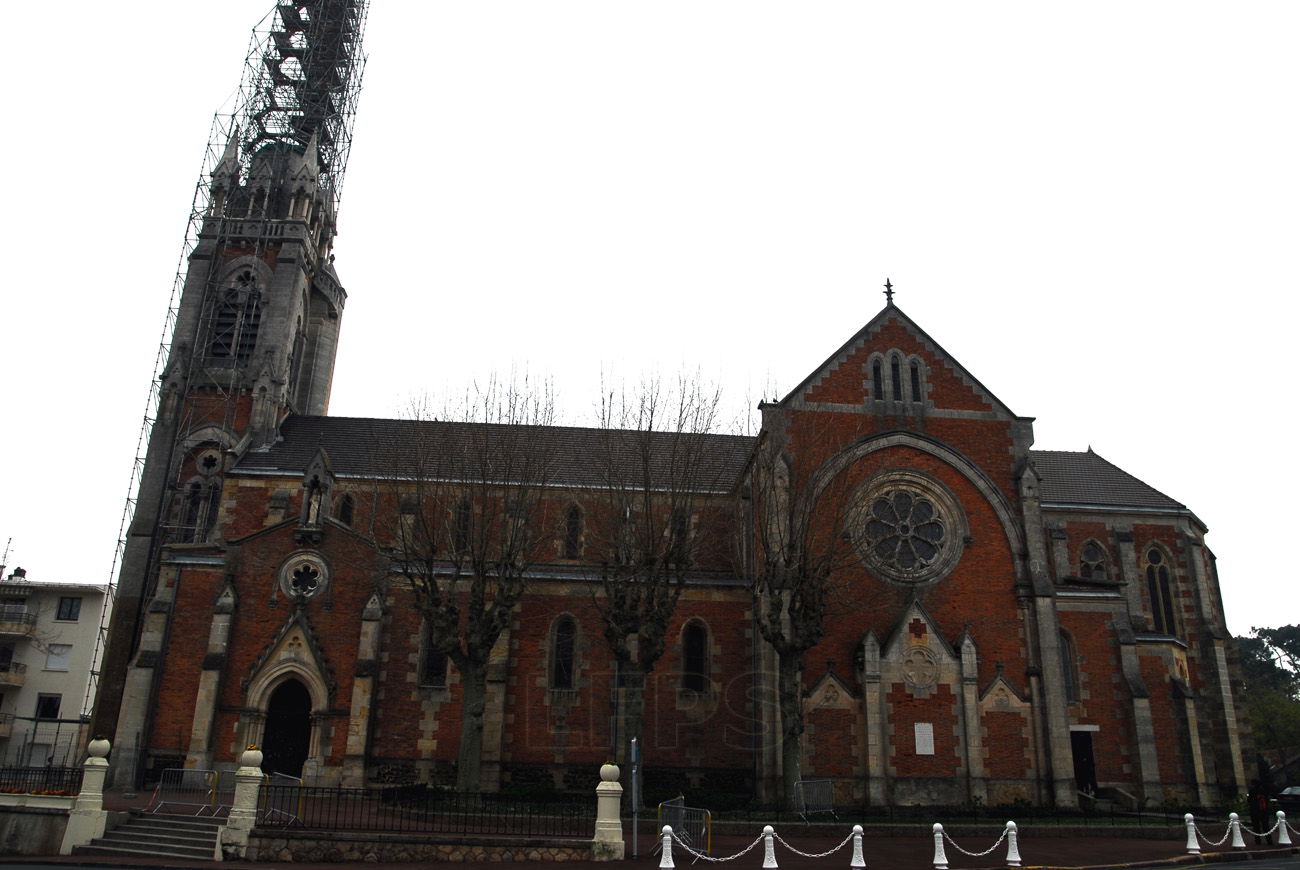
[{"xmin": 111, "ymin": 304, "xmax": 1242, "ymax": 805}]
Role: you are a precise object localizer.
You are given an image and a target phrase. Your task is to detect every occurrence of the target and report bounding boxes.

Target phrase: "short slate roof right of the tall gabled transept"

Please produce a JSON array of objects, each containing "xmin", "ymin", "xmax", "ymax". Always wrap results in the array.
[{"xmin": 1030, "ymin": 450, "xmax": 1187, "ymax": 511}]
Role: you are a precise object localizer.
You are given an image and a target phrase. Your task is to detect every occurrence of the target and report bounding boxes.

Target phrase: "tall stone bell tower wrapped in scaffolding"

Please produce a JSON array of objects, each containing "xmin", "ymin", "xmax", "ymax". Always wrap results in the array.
[{"xmin": 94, "ymin": 0, "xmax": 368, "ymax": 785}]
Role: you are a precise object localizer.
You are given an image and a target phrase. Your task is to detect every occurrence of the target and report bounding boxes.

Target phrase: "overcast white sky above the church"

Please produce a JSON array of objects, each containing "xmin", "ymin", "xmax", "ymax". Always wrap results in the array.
[{"xmin": 0, "ymin": 0, "xmax": 1300, "ymax": 633}]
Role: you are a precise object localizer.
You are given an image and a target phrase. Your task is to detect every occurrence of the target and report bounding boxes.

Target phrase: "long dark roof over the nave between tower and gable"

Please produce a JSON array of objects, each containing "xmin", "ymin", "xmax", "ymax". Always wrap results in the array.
[{"xmin": 235, "ymin": 415, "xmax": 757, "ymax": 492}]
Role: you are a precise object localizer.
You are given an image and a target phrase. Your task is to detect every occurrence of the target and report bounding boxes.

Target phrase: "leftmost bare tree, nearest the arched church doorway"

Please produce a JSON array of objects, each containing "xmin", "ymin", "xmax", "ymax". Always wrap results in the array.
[{"xmin": 382, "ymin": 380, "xmax": 555, "ymax": 791}]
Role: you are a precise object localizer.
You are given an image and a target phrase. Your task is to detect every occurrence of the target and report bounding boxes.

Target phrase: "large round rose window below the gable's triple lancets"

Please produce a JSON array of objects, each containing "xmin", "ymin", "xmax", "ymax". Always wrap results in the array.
[{"xmin": 849, "ymin": 471, "xmax": 966, "ymax": 584}]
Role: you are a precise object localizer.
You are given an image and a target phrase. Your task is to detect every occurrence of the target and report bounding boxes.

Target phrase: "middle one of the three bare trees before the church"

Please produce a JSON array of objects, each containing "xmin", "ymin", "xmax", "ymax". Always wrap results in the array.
[{"xmin": 586, "ymin": 376, "xmax": 737, "ymax": 785}]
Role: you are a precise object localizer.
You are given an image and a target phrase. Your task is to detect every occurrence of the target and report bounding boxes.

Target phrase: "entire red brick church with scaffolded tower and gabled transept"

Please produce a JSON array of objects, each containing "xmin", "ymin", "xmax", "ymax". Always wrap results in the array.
[{"xmin": 95, "ymin": 0, "xmax": 1244, "ymax": 808}]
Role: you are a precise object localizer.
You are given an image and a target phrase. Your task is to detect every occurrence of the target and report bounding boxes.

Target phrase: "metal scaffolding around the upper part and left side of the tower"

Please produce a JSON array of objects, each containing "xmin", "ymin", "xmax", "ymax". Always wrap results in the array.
[{"xmin": 92, "ymin": 0, "xmax": 369, "ymax": 714}]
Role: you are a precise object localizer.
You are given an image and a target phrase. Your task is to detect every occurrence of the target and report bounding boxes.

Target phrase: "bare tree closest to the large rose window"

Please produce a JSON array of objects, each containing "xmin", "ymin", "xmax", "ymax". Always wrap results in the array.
[{"xmin": 741, "ymin": 406, "xmax": 853, "ymax": 809}]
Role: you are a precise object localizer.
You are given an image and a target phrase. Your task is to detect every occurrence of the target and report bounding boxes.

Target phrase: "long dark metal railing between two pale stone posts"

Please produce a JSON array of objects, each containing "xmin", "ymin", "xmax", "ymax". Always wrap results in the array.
[{"xmin": 257, "ymin": 783, "xmax": 594, "ymax": 837}]
